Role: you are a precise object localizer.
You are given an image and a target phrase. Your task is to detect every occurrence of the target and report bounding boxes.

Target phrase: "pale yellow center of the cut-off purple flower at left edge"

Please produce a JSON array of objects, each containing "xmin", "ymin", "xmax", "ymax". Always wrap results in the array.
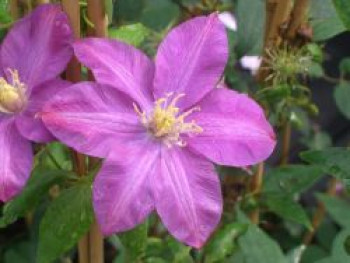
[{"xmin": 0, "ymin": 69, "xmax": 26, "ymax": 113}]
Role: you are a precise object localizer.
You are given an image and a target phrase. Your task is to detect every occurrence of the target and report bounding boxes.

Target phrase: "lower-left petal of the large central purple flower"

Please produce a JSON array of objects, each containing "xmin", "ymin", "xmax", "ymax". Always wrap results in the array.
[{"xmin": 93, "ymin": 141, "xmax": 160, "ymax": 235}]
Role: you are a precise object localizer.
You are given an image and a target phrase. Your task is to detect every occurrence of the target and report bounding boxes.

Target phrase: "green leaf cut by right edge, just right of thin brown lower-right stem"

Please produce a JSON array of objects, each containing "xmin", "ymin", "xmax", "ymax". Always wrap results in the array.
[{"xmin": 317, "ymin": 194, "xmax": 350, "ymax": 228}]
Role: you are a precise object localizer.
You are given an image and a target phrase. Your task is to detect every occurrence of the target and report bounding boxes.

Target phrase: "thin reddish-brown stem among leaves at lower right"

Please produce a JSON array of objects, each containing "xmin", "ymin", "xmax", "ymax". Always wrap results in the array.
[{"xmin": 303, "ymin": 177, "xmax": 337, "ymax": 246}]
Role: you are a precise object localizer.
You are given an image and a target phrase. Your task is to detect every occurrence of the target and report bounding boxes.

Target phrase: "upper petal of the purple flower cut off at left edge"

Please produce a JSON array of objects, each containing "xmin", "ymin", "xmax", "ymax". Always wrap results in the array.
[{"xmin": 1, "ymin": 4, "xmax": 73, "ymax": 88}]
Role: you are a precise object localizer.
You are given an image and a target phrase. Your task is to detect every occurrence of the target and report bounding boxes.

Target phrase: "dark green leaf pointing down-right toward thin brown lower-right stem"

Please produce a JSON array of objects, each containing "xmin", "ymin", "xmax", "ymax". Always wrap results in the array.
[{"xmin": 263, "ymin": 193, "xmax": 312, "ymax": 229}]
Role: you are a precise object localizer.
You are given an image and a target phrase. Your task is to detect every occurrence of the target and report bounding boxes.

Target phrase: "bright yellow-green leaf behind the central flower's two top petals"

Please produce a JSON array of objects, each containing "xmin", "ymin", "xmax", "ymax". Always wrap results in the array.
[{"xmin": 108, "ymin": 23, "xmax": 150, "ymax": 47}]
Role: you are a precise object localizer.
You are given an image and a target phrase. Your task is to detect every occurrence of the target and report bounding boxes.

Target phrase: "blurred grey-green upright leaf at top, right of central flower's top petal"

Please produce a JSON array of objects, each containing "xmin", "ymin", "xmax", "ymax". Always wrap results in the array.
[{"xmin": 236, "ymin": 0, "xmax": 266, "ymax": 57}]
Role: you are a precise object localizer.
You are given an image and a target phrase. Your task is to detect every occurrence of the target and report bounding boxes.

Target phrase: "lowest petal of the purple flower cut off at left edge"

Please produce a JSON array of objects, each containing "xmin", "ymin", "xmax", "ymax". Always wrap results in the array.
[{"xmin": 0, "ymin": 118, "xmax": 33, "ymax": 202}]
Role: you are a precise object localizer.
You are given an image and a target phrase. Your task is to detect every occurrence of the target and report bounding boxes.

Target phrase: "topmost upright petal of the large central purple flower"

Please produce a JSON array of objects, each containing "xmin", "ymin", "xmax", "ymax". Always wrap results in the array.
[{"xmin": 154, "ymin": 14, "xmax": 228, "ymax": 108}]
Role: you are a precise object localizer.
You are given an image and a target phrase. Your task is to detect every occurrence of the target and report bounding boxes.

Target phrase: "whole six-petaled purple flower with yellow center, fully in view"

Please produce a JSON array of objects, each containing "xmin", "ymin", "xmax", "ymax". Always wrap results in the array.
[{"xmin": 42, "ymin": 14, "xmax": 275, "ymax": 248}]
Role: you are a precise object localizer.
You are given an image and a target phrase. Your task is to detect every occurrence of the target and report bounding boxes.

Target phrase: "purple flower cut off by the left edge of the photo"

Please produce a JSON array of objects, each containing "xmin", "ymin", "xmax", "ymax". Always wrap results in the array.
[{"xmin": 0, "ymin": 5, "xmax": 73, "ymax": 202}]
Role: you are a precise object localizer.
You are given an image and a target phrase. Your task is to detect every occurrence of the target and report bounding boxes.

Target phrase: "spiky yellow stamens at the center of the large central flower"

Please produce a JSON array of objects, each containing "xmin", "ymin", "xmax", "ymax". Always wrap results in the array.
[{"xmin": 134, "ymin": 93, "xmax": 203, "ymax": 147}]
